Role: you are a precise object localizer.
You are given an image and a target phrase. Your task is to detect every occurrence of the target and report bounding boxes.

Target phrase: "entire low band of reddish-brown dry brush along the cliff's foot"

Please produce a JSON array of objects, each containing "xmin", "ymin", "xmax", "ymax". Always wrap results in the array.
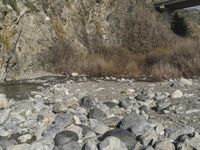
[{"xmin": 38, "ymin": 38, "xmax": 200, "ymax": 80}]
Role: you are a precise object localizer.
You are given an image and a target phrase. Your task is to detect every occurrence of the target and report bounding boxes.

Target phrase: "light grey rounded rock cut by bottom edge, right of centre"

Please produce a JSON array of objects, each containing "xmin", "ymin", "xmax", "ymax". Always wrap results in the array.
[{"xmin": 155, "ymin": 139, "xmax": 175, "ymax": 150}]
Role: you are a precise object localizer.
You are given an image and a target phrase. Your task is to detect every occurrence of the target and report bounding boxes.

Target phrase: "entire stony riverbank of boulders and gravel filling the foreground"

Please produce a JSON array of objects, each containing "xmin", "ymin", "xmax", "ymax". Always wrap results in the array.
[{"xmin": 0, "ymin": 77, "xmax": 200, "ymax": 150}]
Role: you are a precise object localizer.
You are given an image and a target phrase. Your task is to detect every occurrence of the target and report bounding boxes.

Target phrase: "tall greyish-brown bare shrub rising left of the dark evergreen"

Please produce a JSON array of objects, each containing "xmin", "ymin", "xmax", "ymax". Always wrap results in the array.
[{"xmin": 123, "ymin": 6, "xmax": 176, "ymax": 52}]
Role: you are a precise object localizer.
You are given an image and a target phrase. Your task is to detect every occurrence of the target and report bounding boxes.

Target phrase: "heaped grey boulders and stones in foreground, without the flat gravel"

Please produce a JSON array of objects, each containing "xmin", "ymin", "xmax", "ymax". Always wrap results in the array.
[{"xmin": 0, "ymin": 78, "xmax": 200, "ymax": 150}]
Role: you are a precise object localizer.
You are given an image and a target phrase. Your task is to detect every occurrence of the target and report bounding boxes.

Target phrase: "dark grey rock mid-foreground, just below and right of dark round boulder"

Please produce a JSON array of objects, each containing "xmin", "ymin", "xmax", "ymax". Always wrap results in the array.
[{"xmin": 88, "ymin": 108, "xmax": 105, "ymax": 121}]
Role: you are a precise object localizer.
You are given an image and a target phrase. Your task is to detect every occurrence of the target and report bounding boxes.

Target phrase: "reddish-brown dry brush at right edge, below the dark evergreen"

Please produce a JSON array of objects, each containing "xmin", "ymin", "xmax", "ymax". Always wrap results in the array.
[{"xmin": 146, "ymin": 39, "xmax": 200, "ymax": 80}]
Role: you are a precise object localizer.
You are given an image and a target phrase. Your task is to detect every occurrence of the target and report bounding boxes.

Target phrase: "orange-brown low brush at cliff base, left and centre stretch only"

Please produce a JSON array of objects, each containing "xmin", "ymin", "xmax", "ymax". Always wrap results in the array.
[{"xmin": 38, "ymin": 42, "xmax": 145, "ymax": 78}]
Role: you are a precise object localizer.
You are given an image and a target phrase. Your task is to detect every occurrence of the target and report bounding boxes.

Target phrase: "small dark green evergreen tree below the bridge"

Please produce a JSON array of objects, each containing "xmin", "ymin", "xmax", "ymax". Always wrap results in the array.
[{"xmin": 171, "ymin": 12, "xmax": 189, "ymax": 37}]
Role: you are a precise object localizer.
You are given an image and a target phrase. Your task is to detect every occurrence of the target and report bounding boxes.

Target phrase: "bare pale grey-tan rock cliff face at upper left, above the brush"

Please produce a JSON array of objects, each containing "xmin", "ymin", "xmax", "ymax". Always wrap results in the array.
[{"xmin": 0, "ymin": 0, "xmax": 141, "ymax": 79}]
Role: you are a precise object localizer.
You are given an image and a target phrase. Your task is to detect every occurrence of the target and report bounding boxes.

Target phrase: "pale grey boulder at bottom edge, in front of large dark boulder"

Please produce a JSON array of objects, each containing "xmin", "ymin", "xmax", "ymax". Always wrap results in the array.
[{"xmin": 99, "ymin": 136, "xmax": 128, "ymax": 150}]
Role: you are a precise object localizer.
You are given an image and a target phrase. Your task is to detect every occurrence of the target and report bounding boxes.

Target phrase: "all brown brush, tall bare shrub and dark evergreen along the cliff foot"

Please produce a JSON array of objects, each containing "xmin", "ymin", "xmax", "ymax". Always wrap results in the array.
[{"xmin": 40, "ymin": 3, "xmax": 200, "ymax": 80}]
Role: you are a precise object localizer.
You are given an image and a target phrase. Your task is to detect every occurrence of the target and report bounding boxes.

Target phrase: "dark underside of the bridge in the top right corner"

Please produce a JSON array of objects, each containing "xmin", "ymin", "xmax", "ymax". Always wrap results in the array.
[{"xmin": 154, "ymin": 0, "xmax": 200, "ymax": 12}]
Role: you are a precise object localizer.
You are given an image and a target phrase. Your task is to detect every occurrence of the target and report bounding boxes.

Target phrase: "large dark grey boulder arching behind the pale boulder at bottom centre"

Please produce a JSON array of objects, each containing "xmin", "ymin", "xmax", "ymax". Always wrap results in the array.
[{"xmin": 103, "ymin": 128, "xmax": 137, "ymax": 149}]
